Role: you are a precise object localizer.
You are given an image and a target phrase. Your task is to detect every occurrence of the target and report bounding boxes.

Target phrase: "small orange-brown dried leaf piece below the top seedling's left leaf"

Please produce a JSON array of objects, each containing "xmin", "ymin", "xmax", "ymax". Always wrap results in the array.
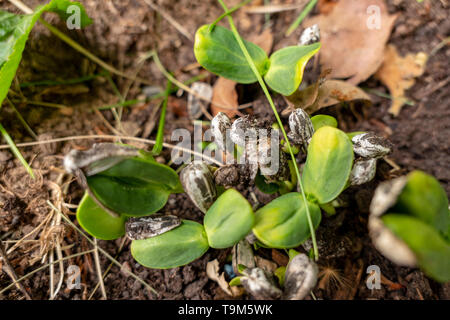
[{"xmin": 211, "ymin": 77, "xmax": 239, "ymax": 118}]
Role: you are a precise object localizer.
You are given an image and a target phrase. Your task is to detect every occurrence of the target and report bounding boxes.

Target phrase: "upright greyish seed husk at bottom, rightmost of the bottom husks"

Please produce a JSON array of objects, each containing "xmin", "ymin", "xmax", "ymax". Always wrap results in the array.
[{"xmin": 283, "ymin": 253, "xmax": 319, "ymax": 300}]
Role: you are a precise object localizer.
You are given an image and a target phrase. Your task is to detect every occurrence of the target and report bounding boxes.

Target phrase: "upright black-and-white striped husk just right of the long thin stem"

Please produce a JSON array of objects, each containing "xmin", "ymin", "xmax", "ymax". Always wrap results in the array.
[{"xmin": 288, "ymin": 108, "xmax": 314, "ymax": 148}]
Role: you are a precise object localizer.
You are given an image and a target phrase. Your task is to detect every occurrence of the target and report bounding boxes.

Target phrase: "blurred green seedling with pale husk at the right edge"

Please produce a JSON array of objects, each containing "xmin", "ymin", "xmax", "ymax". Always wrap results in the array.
[{"xmin": 369, "ymin": 171, "xmax": 450, "ymax": 283}]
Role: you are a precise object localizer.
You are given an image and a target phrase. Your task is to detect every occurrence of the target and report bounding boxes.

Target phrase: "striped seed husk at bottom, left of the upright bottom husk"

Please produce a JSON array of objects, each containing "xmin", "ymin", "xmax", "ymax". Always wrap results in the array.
[{"xmin": 241, "ymin": 268, "xmax": 282, "ymax": 300}]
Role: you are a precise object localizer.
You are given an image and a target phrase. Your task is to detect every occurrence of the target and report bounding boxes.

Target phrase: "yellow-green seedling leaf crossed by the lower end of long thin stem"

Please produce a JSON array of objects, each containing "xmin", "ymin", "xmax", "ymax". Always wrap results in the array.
[{"xmin": 253, "ymin": 192, "xmax": 322, "ymax": 249}]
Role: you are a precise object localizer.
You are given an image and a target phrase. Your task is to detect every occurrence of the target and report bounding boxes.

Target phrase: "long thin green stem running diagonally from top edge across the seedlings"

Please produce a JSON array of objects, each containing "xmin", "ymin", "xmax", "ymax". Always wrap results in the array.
[{"xmin": 218, "ymin": 0, "xmax": 319, "ymax": 260}]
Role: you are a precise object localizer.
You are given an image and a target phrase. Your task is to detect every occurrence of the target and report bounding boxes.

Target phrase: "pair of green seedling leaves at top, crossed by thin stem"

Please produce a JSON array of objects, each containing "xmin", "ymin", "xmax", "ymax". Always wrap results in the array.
[{"xmin": 194, "ymin": 25, "xmax": 320, "ymax": 95}]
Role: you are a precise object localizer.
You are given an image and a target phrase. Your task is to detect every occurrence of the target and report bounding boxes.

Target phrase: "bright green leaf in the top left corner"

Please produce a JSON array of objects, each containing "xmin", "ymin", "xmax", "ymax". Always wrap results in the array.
[{"xmin": 0, "ymin": 0, "xmax": 92, "ymax": 107}]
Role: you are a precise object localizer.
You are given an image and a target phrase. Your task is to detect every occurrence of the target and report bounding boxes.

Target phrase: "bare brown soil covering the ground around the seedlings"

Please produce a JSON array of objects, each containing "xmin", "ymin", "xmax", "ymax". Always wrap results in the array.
[{"xmin": 0, "ymin": 0, "xmax": 450, "ymax": 300}]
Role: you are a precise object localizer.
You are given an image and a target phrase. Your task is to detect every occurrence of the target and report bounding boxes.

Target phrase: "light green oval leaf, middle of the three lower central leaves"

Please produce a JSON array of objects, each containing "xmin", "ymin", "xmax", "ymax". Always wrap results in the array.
[{"xmin": 204, "ymin": 189, "xmax": 255, "ymax": 249}]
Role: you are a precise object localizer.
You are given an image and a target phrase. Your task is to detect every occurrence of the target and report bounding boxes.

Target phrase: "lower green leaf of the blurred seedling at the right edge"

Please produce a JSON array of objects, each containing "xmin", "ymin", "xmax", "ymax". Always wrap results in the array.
[{"xmin": 381, "ymin": 213, "xmax": 450, "ymax": 282}]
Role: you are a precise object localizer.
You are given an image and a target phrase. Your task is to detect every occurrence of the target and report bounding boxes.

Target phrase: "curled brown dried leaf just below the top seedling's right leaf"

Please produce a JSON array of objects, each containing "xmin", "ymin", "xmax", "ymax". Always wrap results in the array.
[{"xmin": 283, "ymin": 80, "xmax": 371, "ymax": 114}]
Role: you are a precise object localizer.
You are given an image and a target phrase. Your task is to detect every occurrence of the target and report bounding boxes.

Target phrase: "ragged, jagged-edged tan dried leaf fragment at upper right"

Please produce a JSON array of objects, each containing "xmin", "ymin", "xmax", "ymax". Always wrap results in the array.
[{"xmin": 375, "ymin": 45, "xmax": 428, "ymax": 116}]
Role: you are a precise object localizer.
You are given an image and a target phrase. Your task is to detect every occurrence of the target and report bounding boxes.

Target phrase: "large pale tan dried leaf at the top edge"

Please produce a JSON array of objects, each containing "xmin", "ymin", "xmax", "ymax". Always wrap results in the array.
[{"xmin": 305, "ymin": 0, "xmax": 397, "ymax": 85}]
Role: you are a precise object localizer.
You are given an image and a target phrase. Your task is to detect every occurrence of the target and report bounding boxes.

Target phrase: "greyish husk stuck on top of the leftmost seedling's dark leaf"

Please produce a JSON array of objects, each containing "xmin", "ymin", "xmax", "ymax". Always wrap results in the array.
[{"xmin": 64, "ymin": 143, "xmax": 139, "ymax": 177}]
